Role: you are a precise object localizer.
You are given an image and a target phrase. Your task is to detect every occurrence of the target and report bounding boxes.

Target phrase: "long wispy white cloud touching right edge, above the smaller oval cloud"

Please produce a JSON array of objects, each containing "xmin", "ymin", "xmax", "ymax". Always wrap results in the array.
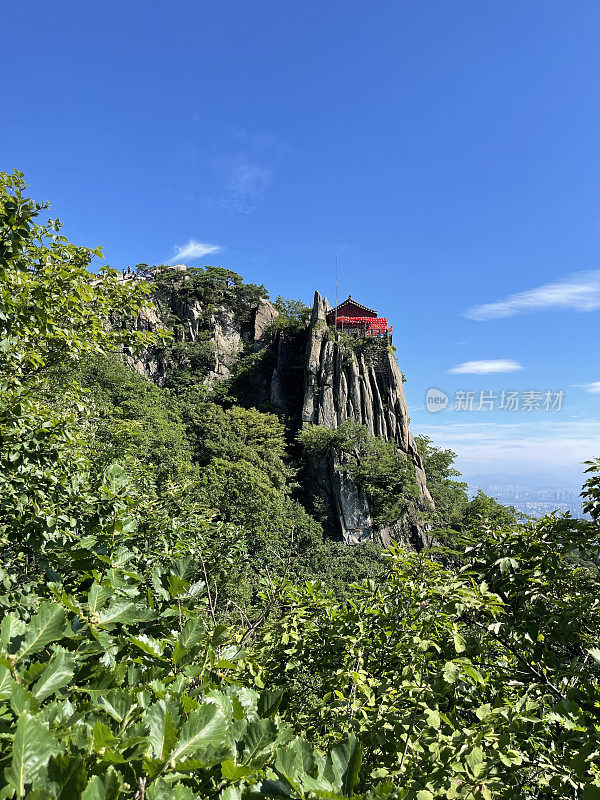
[{"xmin": 465, "ymin": 270, "xmax": 600, "ymax": 321}]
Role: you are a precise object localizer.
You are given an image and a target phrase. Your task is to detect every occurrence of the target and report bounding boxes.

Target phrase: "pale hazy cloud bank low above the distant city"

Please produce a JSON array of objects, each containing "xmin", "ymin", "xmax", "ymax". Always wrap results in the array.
[{"xmin": 414, "ymin": 415, "xmax": 600, "ymax": 482}]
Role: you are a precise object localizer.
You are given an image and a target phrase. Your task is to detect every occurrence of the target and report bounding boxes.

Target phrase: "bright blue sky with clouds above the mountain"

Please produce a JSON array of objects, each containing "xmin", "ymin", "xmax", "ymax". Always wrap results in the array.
[{"xmin": 0, "ymin": 0, "xmax": 600, "ymax": 480}]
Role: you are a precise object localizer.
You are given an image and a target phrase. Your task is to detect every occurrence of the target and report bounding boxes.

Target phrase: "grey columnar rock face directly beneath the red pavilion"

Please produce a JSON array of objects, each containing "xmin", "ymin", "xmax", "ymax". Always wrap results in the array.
[{"xmin": 302, "ymin": 292, "xmax": 433, "ymax": 548}]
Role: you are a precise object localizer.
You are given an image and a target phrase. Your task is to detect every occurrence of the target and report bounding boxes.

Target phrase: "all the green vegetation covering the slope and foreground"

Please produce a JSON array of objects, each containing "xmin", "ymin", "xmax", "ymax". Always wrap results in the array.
[{"xmin": 0, "ymin": 174, "xmax": 600, "ymax": 800}]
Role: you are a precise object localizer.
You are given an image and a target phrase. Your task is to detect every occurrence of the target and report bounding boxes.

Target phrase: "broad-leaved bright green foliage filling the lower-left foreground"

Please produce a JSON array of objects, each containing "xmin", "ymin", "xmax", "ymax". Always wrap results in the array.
[{"xmin": 0, "ymin": 541, "xmax": 368, "ymax": 800}]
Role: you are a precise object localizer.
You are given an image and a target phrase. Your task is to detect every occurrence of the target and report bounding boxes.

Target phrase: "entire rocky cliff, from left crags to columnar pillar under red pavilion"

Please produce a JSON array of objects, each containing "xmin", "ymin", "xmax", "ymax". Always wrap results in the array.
[{"xmin": 122, "ymin": 277, "xmax": 432, "ymax": 549}]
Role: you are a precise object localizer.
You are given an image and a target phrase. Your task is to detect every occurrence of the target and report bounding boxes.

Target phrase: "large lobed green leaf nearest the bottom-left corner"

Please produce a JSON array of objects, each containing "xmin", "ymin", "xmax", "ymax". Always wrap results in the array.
[{"xmin": 5, "ymin": 713, "xmax": 62, "ymax": 797}]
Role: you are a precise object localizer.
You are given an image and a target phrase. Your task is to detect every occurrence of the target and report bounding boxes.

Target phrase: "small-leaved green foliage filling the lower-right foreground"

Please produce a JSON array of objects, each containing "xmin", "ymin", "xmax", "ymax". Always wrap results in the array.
[{"xmin": 244, "ymin": 519, "xmax": 600, "ymax": 798}]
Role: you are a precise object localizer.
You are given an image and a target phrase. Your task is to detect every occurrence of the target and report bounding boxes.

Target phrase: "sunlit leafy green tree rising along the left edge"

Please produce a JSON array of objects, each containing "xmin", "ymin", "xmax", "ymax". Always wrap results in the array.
[{"xmin": 0, "ymin": 173, "xmax": 153, "ymax": 588}]
